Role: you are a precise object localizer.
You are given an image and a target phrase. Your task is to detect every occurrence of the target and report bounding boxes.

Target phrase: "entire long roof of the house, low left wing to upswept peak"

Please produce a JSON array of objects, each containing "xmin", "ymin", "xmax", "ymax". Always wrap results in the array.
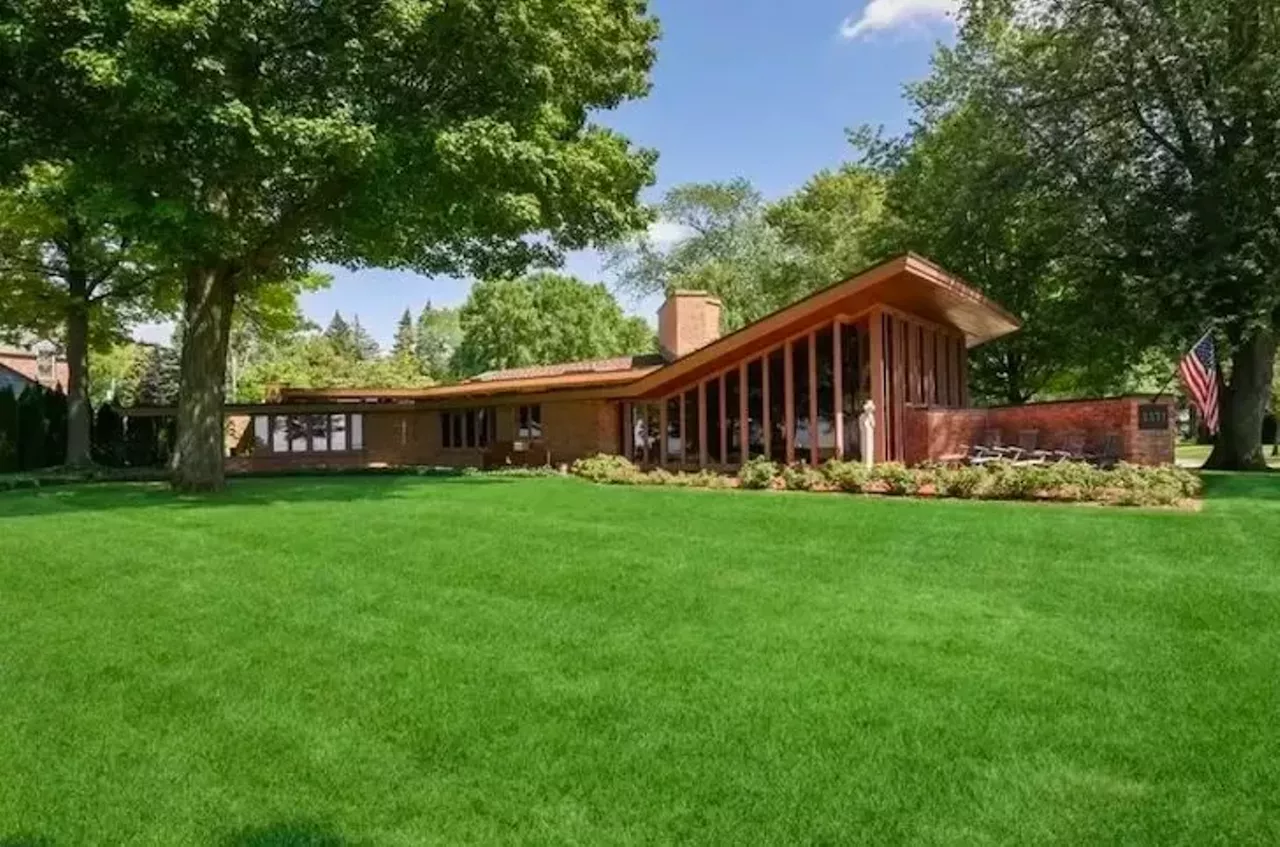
[{"xmin": 282, "ymin": 253, "xmax": 1021, "ymax": 402}]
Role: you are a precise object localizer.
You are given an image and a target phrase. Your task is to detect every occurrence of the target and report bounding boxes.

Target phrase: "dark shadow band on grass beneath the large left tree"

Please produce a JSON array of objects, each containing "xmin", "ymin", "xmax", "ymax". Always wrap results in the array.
[{"xmin": 0, "ymin": 475, "xmax": 535, "ymax": 522}]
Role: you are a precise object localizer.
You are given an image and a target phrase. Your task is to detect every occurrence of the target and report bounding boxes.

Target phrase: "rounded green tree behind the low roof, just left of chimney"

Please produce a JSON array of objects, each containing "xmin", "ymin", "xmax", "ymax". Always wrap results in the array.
[{"xmin": 456, "ymin": 273, "xmax": 654, "ymax": 376}]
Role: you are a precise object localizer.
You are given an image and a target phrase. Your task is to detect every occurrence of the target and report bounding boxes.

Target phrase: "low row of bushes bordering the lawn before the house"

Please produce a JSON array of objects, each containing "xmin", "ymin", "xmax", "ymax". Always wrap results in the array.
[{"xmin": 571, "ymin": 454, "xmax": 1201, "ymax": 505}]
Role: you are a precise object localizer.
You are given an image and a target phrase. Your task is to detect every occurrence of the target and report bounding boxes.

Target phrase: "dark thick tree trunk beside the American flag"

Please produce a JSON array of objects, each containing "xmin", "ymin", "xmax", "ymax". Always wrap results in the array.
[{"xmin": 1204, "ymin": 330, "xmax": 1276, "ymax": 471}]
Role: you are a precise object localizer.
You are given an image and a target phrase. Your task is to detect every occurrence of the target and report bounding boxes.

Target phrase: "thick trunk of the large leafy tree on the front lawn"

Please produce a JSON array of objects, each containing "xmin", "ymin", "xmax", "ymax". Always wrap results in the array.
[{"xmin": 173, "ymin": 265, "xmax": 236, "ymax": 491}]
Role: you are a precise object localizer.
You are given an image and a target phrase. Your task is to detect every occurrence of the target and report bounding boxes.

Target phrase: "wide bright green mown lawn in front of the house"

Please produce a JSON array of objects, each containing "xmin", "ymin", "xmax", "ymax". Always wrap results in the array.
[{"xmin": 0, "ymin": 475, "xmax": 1280, "ymax": 847}]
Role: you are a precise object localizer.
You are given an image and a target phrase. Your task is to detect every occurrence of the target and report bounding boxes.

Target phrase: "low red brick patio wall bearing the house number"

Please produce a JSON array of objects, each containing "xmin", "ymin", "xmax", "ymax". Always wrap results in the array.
[{"xmin": 905, "ymin": 397, "xmax": 1175, "ymax": 464}]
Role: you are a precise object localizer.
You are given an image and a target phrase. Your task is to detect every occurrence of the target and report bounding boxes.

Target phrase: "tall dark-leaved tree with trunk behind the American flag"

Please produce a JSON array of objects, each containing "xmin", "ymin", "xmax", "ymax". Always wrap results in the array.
[{"xmin": 960, "ymin": 0, "xmax": 1280, "ymax": 468}]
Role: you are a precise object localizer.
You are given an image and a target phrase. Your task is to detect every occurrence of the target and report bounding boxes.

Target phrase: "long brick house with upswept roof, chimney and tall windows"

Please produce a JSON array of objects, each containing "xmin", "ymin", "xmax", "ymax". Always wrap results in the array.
[{"xmin": 124, "ymin": 255, "xmax": 1174, "ymax": 470}]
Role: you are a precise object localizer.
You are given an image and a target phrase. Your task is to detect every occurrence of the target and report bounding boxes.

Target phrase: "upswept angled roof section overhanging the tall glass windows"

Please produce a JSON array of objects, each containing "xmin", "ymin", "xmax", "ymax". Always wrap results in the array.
[{"xmin": 628, "ymin": 253, "xmax": 1021, "ymax": 398}]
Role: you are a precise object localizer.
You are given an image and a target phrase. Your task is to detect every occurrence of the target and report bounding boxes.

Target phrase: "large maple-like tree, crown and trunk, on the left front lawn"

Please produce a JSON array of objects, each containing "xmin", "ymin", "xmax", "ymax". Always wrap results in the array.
[{"xmin": 0, "ymin": 0, "xmax": 658, "ymax": 489}]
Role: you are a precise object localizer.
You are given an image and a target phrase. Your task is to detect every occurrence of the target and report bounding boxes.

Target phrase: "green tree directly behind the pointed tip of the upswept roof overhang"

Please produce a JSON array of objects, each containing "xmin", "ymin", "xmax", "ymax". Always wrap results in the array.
[{"xmin": 870, "ymin": 86, "xmax": 1149, "ymax": 404}]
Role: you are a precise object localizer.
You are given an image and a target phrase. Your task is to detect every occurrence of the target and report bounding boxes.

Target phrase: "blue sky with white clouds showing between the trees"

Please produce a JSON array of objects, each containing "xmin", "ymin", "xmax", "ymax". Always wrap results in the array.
[{"xmin": 145, "ymin": 0, "xmax": 956, "ymax": 344}]
